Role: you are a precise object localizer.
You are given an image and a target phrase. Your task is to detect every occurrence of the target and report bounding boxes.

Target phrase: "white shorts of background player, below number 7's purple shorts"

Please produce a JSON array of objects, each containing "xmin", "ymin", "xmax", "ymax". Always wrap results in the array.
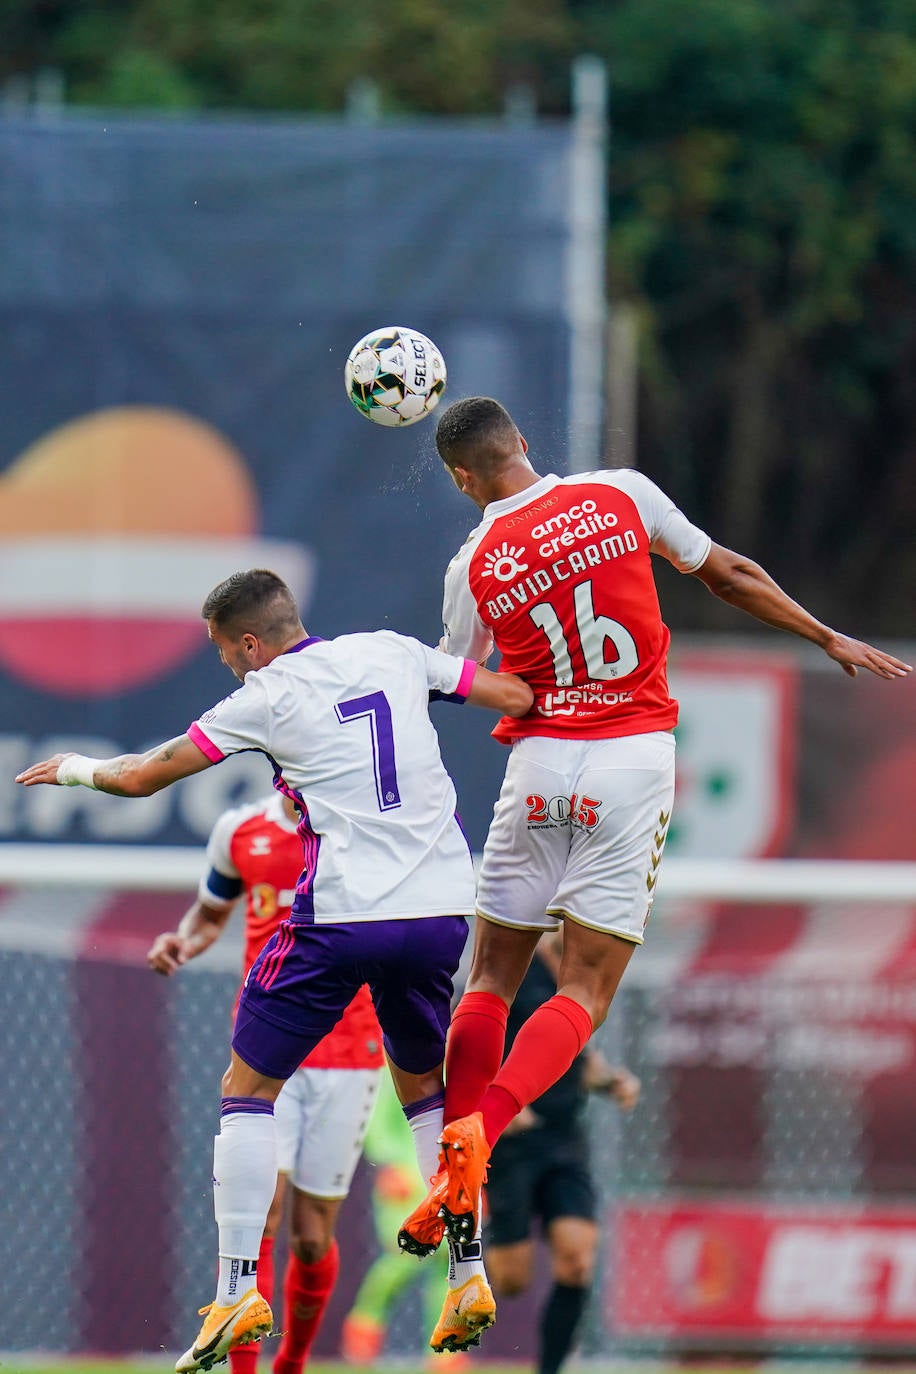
[{"xmin": 273, "ymin": 1069, "xmax": 385, "ymax": 1198}]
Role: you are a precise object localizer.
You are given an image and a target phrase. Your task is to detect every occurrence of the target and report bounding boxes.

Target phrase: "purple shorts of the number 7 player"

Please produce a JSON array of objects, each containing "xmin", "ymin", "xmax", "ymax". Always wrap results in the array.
[{"xmin": 232, "ymin": 916, "xmax": 467, "ymax": 1079}]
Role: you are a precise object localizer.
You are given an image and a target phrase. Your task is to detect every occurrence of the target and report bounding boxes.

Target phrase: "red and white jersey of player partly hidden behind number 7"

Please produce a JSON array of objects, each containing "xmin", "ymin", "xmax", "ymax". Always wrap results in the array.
[{"xmin": 198, "ymin": 793, "xmax": 385, "ymax": 1069}]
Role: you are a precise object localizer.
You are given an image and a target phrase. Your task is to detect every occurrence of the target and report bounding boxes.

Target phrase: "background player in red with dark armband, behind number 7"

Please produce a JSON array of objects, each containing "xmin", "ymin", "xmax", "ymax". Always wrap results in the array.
[{"xmin": 147, "ymin": 793, "xmax": 385, "ymax": 1374}]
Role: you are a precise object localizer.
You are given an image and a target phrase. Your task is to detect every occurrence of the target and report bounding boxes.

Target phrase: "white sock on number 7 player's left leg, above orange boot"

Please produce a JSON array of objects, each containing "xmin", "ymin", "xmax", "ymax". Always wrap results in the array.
[{"xmin": 213, "ymin": 1099, "xmax": 276, "ymax": 1307}]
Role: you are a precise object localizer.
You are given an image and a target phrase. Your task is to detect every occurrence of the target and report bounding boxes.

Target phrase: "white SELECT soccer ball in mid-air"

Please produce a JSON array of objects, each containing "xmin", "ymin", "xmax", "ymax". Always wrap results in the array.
[{"xmin": 343, "ymin": 324, "xmax": 445, "ymax": 427}]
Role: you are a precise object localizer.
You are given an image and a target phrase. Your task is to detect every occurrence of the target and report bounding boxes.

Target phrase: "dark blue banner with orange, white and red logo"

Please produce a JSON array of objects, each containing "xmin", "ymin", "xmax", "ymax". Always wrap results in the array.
[{"xmin": 0, "ymin": 118, "xmax": 570, "ymax": 846}]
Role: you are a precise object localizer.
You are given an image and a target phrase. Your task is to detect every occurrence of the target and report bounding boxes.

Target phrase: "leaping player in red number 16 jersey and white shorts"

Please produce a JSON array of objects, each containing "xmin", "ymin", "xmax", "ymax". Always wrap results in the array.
[{"xmin": 404, "ymin": 397, "xmax": 911, "ymax": 1258}]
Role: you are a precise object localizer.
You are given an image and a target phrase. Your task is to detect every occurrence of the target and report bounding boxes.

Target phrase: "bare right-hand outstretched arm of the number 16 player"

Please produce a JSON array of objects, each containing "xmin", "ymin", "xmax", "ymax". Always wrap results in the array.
[{"xmin": 694, "ymin": 544, "xmax": 913, "ymax": 677}]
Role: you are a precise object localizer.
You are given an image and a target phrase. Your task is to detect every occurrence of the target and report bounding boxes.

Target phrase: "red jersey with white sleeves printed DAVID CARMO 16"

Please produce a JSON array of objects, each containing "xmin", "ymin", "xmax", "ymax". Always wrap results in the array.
[{"xmin": 439, "ymin": 469, "xmax": 711, "ymax": 743}]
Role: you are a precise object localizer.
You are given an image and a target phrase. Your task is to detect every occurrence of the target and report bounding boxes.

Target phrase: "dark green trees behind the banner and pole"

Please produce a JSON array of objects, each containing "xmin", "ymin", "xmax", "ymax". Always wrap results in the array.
[{"xmin": 0, "ymin": 0, "xmax": 916, "ymax": 635}]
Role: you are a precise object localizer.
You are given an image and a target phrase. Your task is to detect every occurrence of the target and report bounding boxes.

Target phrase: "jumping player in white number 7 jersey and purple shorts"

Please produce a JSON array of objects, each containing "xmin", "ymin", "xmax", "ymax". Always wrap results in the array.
[{"xmin": 16, "ymin": 569, "xmax": 531, "ymax": 1371}]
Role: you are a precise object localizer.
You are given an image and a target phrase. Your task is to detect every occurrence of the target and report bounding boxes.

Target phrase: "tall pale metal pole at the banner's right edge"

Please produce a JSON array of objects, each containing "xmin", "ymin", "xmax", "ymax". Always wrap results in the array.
[{"xmin": 566, "ymin": 56, "xmax": 607, "ymax": 473}]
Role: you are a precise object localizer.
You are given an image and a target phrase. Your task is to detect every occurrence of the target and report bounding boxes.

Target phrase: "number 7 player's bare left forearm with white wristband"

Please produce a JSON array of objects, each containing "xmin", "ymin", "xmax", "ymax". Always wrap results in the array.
[{"xmin": 16, "ymin": 735, "xmax": 211, "ymax": 797}]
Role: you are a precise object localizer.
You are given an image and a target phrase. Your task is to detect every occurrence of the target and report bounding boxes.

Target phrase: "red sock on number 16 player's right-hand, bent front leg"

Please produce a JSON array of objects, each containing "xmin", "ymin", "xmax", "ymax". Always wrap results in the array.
[{"xmin": 479, "ymin": 993, "xmax": 592, "ymax": 1146}]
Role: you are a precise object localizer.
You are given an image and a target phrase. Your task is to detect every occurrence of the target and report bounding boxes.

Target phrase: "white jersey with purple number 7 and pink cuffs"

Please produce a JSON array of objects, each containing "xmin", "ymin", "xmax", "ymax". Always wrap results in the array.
[{"xmin": 188, "ymin": 631, "xmax": 475, "ymax": 923}]
